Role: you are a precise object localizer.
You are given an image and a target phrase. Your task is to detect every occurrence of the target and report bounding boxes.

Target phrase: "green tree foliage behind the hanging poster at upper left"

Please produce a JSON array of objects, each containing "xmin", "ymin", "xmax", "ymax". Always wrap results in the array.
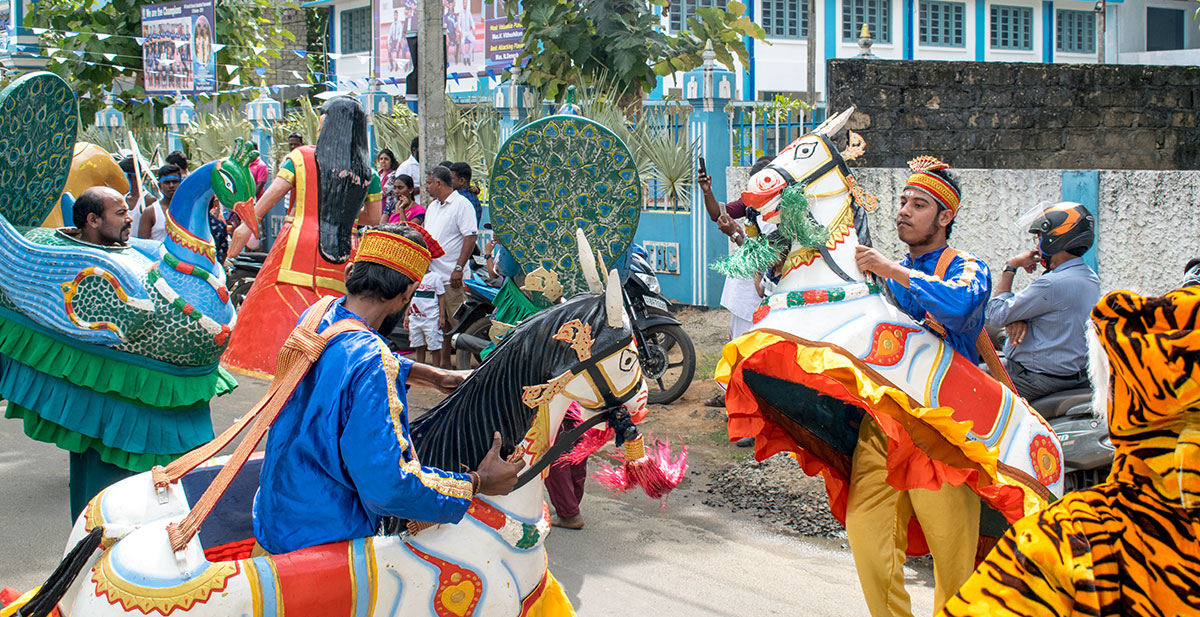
[{"xmin": 28, "ymin": 0, "xmax": 298, "ymax": 120}]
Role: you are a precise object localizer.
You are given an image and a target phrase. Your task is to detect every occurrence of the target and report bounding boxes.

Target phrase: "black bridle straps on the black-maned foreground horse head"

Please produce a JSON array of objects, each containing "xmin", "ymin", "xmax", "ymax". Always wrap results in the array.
[{"xmin": 514, "ymin": 333, "xmax": 637, "ymax": 490}]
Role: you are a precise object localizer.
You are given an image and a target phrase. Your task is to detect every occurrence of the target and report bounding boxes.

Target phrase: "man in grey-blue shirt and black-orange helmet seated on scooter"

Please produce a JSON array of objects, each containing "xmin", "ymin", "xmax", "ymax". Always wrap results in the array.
[{"xmin": 988, "ymin": 202, "xmax": 1100, "ymax": 401}]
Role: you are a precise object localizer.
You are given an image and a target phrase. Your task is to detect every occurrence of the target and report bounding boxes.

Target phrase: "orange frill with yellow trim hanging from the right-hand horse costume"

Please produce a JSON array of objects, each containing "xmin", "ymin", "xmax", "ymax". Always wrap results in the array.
[{"xmin": 715, "ymin": 331, "xmax": 1044, "ymax": 556}]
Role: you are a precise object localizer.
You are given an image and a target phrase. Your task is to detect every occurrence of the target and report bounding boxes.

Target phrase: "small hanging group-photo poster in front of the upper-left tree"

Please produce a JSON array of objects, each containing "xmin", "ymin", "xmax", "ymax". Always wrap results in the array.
[{"xmin": 142, "ymin": 0, "xmax": 217, "ymax": 94}]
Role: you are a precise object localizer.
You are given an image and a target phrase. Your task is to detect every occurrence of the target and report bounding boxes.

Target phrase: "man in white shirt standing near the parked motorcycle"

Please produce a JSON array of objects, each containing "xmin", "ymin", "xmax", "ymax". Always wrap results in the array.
[{"xmin": 425, "ymin": 166, "xmax": 479, "ymax": 366}]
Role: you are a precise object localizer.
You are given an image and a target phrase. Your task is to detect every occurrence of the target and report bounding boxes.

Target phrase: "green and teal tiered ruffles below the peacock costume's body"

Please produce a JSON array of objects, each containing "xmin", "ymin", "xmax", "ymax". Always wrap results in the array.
[{"xmin": 0, "ymin": 303, "xmax": 238, "ymax": 472}]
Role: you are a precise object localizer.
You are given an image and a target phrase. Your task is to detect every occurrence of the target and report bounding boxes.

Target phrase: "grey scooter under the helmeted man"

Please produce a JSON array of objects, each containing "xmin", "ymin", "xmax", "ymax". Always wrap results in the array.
[{"xmin": 988, "ymin": 327, "xmax": 1115, "ymax": 492}]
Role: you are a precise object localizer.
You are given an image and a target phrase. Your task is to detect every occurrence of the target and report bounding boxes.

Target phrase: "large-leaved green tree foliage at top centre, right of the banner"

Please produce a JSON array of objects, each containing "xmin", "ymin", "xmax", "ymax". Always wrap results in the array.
[{"xmin": 505, "ymin": 0, "xmax": 766, "ymax": 100}]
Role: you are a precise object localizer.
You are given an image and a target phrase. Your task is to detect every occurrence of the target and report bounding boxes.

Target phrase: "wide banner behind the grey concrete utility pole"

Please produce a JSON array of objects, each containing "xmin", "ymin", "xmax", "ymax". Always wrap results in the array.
[{"xmin": 374, "ymin": 0, "xmax": 523, "ymax": 82}]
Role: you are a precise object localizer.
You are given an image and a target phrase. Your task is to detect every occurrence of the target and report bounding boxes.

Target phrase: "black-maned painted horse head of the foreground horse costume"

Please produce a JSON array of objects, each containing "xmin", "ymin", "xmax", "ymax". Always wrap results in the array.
[{"xmin": 412, "ymin": 276, "xmax": 642, "ymax": 469}]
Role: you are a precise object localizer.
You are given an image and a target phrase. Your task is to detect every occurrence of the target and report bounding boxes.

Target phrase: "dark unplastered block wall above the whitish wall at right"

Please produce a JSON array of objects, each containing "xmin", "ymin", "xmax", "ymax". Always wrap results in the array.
[{"xmin": 827, "ymin": 59, "xmax": 1200, "ymax": 169}]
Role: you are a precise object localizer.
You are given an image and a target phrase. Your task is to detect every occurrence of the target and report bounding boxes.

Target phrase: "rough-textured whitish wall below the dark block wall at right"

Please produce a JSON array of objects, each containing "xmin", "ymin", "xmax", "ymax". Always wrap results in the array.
[{"xmin": 718, "ymin": 167, "xmax": 1200, "ymax": 295}]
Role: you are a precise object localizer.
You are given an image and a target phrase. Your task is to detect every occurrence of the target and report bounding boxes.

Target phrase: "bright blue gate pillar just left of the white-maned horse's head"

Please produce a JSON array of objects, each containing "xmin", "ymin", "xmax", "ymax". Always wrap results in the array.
[{"xmin": 680, "ymin": 44, "xmax": 737, "ymax": 307}]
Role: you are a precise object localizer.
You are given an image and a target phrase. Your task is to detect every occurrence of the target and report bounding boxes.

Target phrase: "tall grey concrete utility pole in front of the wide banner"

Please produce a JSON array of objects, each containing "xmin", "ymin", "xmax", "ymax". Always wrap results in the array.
[{"xmin": 414, "ymin": 0, "xmax": 446, "ymax": 196}]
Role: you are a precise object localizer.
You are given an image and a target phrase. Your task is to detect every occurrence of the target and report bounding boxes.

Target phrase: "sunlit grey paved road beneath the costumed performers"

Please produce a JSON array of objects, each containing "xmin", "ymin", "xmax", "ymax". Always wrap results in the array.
[{"xmin": 0, "ymin": 378, "xmax": 932, "ymax": 617}]
